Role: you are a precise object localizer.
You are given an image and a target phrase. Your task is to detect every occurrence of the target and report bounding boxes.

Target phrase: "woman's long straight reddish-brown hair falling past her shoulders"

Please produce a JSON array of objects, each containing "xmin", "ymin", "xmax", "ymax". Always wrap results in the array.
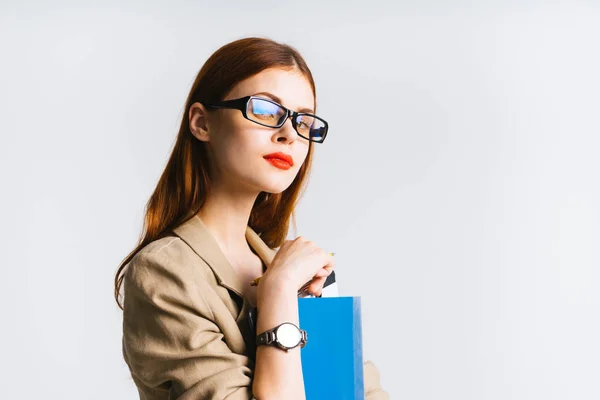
[{"xmin": 114, "ymin": 37, "xmax": 316, "ymax": 309}]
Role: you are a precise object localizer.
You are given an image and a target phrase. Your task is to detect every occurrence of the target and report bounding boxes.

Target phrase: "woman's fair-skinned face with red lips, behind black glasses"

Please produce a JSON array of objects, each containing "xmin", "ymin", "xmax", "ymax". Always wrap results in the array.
[{"xmin": 190, "ymin": 68, "xmax": 315, "ymax": 194}]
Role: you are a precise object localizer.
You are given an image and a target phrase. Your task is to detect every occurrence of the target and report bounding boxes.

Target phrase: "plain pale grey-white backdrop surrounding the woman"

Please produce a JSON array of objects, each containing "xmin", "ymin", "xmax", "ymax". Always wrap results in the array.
[{"xmin": 0, "ymin": 0, "xmax": 600, "ymax": 400}]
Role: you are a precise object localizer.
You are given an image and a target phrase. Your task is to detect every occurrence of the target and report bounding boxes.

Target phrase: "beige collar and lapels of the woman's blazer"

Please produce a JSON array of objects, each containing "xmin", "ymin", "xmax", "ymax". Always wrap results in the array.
[{"xmin": 173, "ymin": 214, "xmax": 275, "ymax": 297}]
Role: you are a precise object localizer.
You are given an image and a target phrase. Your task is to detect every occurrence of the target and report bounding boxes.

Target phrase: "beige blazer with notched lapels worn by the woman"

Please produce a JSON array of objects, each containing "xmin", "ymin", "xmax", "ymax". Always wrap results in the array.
[{"xmin": 123, "ymin": 216, "xmax": 389, "ymax": 400}]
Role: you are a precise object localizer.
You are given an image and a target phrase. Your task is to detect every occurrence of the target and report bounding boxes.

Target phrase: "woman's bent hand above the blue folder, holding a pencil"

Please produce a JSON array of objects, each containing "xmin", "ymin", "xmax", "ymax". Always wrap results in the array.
[{"xmin": 258, "ymin": 236, "xmax": 335, "ymax": 296}]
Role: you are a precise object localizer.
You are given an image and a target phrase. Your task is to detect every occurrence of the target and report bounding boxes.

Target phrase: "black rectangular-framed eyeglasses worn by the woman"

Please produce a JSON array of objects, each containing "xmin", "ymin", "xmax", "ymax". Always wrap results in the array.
[{"xmin": 202, "ymin": 96, "xmax": 329, "ymax": 143}]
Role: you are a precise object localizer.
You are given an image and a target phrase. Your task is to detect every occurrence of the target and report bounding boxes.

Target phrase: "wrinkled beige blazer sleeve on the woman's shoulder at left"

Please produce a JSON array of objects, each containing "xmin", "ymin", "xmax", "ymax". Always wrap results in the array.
[{"xmin": 123, "ymin": 253, "xmax": 253, "ymax": 400}]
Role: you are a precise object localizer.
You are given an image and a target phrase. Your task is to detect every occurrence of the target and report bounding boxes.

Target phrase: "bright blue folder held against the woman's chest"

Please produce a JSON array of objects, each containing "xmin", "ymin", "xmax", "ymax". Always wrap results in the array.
[{"xmin": 298, "ymin": 297, "xmax": 365, "ymax": 400}]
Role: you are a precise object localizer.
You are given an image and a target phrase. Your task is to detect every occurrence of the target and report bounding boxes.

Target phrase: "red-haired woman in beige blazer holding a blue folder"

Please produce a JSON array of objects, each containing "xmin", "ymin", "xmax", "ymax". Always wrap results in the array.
[{"xmin": 115, "ymin": 38, "xmax": 388, "ymax": 400}]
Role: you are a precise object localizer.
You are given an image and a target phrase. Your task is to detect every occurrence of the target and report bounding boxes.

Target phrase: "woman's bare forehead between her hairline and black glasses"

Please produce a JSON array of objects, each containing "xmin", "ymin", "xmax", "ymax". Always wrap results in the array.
[{"xmin": 226, "ymin": 68, "xmax": 315, "ymax": 110}]
